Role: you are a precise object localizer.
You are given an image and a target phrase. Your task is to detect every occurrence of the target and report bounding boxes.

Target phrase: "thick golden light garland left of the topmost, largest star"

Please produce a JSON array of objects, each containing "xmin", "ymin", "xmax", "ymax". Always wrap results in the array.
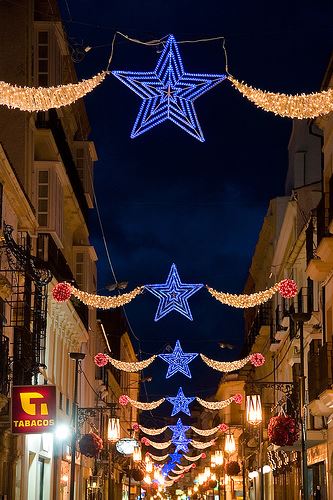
[{"xmin": 0, "ymin": 71, "xmax": 108, "ymax": 112}]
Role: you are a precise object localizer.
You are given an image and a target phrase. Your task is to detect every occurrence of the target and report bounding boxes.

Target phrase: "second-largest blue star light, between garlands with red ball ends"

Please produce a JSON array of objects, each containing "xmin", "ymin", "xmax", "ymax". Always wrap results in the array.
[{"xmin": 145, "ymin": 264, "xmax": 203, "ymax": 322}]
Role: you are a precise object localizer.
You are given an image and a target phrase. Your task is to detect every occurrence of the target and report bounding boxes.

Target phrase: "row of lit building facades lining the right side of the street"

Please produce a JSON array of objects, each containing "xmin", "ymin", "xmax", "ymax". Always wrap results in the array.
[{"xmin": 239, "ymin": 59, "xmax": 333, "ymax": 500}]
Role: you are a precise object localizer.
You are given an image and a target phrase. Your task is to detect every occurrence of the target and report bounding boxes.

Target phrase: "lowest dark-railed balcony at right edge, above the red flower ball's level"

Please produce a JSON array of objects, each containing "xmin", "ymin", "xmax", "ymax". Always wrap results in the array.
[{"xmin": 308, "ymin": 342, "xmax": 333, "ymax": 416}]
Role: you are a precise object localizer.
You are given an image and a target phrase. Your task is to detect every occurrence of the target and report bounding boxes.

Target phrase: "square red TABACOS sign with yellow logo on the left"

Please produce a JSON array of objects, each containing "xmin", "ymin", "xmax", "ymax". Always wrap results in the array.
[{"xmin": 11, "ymin": 385, "xmax": 56, "ymax": 434}]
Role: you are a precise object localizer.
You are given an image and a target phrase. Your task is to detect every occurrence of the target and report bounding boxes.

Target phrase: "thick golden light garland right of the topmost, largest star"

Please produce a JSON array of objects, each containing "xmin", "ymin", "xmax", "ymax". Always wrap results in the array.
[{"xmin": 227, "ymin": 75, "xmax": 333, "ymax": 120}]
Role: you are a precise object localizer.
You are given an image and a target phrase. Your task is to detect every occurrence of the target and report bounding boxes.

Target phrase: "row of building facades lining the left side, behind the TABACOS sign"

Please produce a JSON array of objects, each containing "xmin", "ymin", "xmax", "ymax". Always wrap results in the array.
[{"xmin": 0, "ymin": 0, "xmax": 139, "ymax": 500}]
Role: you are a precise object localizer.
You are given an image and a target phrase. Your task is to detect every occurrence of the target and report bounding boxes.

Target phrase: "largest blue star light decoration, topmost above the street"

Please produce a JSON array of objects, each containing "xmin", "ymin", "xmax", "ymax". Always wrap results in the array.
[{"xmin": 112, "ymin": 35, "xmax": 226, "ymax": 142}]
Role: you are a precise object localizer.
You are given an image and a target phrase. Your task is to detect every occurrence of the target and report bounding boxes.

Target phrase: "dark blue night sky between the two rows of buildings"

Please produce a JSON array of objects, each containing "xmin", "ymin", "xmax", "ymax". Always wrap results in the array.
[{"xmin": 62, "ymin": 0, "xmax": 333, "ymax": 411}]
